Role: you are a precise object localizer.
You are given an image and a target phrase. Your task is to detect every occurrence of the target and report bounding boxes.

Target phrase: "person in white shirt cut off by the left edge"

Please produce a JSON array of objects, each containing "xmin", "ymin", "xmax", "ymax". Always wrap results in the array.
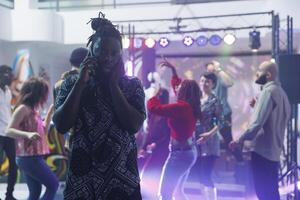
[{"xmin": 0, "ymin": 65, "xmax": 17, "ymax": 200}]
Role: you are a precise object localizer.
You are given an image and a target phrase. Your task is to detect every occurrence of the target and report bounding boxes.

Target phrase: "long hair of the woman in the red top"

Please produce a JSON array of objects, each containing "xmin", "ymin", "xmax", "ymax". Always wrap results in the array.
[{"xmin": 178, "ymin": 80, "xmax": 202, "ymax": 119}]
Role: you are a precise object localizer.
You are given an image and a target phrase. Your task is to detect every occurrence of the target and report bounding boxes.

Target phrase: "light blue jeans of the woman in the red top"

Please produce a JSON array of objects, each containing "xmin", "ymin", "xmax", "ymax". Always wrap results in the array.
[{"xmin": 159, "ymin": 146, "xmax": 197, "ymax": 200}]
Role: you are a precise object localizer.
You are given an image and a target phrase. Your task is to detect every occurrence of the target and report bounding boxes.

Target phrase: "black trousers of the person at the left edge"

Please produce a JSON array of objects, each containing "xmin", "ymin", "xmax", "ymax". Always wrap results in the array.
[{"xmin": 0, "ymin": 136, "xmax": 18, "ymax": 196}]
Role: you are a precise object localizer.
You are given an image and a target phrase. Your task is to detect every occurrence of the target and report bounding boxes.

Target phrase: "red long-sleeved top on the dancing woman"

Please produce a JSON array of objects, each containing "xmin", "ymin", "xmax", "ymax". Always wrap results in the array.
[{"xmin": 147, "ymin": 96, "xmax": 196, "ymax": 141}]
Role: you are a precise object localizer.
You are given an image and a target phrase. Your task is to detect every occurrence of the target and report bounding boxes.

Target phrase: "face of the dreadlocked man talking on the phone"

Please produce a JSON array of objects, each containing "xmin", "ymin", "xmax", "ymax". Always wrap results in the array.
[{"xmin": 91, "ymin": 38, "xmax": 121, "ymax": 76}]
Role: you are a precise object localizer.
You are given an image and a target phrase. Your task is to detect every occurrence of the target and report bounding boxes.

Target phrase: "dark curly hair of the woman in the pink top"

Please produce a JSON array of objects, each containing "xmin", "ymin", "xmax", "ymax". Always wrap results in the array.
[{"xmin": 16, "ymin": 77, "xmax": 49, "ymax": 108}]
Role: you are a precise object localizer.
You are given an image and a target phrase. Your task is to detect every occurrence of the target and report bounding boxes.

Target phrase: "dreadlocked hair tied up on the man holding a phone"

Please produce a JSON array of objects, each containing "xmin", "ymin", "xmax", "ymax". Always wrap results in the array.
[{"xmin": 87, "ymin": 12, "xmax": 122, "ymax": 48}]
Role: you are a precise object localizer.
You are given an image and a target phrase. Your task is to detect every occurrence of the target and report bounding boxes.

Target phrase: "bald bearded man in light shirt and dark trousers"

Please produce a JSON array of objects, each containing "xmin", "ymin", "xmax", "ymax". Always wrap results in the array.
[{"xmin": 229, "ymin": 61, "xmax": 291, "ymax": 200}]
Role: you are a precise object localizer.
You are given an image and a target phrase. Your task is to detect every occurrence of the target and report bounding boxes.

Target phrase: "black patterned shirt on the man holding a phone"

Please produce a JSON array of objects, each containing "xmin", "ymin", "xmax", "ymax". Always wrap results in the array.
[{"xmin": 55, "ymin": 76, "xmax": 146, "ymax": 200}]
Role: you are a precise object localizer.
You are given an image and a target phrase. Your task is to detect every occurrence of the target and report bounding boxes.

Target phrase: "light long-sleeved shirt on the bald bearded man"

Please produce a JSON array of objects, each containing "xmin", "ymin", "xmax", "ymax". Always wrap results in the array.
[{"xmin": 239, "ymin": 81, "xmax": 291, "ymax": 161}]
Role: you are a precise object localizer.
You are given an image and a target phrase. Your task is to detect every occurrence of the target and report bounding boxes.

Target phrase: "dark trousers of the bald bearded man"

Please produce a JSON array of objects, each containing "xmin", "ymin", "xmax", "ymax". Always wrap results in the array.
[{"xmin": 251, "ymin": 152, "xmax": 280, "ymax": 200}]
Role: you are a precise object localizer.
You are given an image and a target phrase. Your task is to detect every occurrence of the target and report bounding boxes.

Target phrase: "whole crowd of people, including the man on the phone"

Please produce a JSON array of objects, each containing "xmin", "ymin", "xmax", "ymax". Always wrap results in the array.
[{"xmin": 0, "ymin": 13, "xmax": 290, "ymax": 200}]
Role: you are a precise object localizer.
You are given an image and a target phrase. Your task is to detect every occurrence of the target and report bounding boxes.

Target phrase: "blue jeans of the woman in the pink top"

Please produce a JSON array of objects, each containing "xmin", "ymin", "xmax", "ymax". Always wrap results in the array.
[{"xmin": 17, "ymin": 156, "xmax": 58, "ymax": 200}]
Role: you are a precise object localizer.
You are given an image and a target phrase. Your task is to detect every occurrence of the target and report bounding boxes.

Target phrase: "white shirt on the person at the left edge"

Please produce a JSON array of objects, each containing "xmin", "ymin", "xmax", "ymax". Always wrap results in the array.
[{"xmin": 0, "ymin": 86, "xmax": 12, "ymax": 136}]
